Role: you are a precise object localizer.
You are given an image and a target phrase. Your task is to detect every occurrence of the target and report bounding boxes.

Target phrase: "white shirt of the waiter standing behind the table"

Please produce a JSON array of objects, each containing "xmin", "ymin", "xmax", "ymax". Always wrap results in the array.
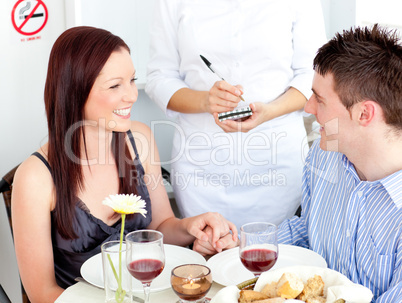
[{"xmin": 145, "ymin": 0, "xmax": 325, "ymax": 131}]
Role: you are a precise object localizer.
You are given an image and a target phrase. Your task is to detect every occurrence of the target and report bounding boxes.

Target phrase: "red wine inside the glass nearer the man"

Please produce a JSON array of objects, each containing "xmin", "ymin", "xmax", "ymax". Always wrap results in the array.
[{"xmin": 240, "ymin": 249, "xmax": 278, "ymax": 273}]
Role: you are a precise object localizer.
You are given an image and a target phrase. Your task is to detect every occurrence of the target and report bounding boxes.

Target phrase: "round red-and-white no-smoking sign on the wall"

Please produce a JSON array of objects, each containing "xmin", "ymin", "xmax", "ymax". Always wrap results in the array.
[{"xmin": 11, "ymin": 0, "xmax": 48, "ymax": 36}]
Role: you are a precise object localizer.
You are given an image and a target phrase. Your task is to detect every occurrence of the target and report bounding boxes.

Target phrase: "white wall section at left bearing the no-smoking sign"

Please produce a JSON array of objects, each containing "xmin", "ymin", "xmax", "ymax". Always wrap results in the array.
[{"xmin": 0, "ymin": 0, "xmax": 65, "ymax": 176}]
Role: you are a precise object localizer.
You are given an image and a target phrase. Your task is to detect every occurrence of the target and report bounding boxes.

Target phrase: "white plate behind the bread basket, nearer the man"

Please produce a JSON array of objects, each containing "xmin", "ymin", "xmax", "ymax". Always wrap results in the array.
[{"xmin": 207, "ymin": 244, "xmax": 327, "ymax": 286}]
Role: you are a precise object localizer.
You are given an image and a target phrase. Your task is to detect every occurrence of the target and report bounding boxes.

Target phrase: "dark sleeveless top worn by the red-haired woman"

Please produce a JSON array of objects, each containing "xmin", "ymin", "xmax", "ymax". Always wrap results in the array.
[{"xmin": 33, "ymin": 131, "xmax": 152, "ymax": 288}]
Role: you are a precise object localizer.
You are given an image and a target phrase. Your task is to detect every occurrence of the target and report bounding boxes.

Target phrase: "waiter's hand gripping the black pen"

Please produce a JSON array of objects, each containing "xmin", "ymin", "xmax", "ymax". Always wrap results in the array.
[{"xmin": 205, "ymin": 81, "xmax": 243, "ymax": 114}]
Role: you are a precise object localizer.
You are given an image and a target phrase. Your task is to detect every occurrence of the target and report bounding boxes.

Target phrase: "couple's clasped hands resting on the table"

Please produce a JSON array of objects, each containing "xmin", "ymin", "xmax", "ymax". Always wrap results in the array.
[{"xmin": 189, "ymin": 213, "xmax": 238, "ymax": 255}]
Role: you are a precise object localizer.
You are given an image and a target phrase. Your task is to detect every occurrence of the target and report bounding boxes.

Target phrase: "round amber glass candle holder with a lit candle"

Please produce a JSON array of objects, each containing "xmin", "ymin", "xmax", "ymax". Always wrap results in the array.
[{"xmin": 170, "ymin": 264, "xmax": 212, "ymax": 303}]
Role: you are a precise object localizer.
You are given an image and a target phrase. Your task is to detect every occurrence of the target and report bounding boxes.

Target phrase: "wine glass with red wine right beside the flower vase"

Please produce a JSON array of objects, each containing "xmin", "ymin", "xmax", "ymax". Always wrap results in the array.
[{"xmin": 126, "ymin": 230, "xmax": 165, "ymax": 303}]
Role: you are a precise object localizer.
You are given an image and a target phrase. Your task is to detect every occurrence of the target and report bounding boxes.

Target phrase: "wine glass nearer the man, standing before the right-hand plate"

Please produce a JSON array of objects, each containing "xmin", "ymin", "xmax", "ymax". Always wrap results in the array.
[{"xmin": 239, "ymin": 222, "xmax": 278, "ymax": 277}]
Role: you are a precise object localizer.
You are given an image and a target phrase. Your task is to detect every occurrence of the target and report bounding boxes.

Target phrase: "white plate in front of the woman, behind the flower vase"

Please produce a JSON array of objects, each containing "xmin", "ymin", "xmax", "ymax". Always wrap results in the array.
[{"xmin": 81, "ymin": 244, "xmax": 206, "ymax": 292}]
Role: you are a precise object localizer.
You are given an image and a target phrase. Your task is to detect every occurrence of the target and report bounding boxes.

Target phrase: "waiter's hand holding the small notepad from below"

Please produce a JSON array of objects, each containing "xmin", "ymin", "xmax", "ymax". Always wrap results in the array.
[{"xmin": 214, "ymin": 102, "xmax": 271, "ymax": 133}]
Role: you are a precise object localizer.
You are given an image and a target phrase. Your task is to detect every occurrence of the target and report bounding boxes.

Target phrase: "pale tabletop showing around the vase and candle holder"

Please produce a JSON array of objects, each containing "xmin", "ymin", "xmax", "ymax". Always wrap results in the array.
[{"xmin": 55, "ymin": 282, "xmax": 224, "ymax": 303}]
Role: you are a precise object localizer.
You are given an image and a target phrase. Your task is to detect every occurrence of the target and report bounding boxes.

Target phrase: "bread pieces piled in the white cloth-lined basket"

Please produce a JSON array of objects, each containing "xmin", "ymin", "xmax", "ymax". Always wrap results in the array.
[{"xmin": 239, "ymin": 272, "xmax": 326, "ymax": 303}]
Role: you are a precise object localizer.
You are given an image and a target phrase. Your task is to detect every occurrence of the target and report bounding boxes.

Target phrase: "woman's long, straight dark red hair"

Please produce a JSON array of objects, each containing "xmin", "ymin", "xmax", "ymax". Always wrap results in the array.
[{"xmin": 44, "ymin": 26, "xmax": 137, "ymax": 239}]
